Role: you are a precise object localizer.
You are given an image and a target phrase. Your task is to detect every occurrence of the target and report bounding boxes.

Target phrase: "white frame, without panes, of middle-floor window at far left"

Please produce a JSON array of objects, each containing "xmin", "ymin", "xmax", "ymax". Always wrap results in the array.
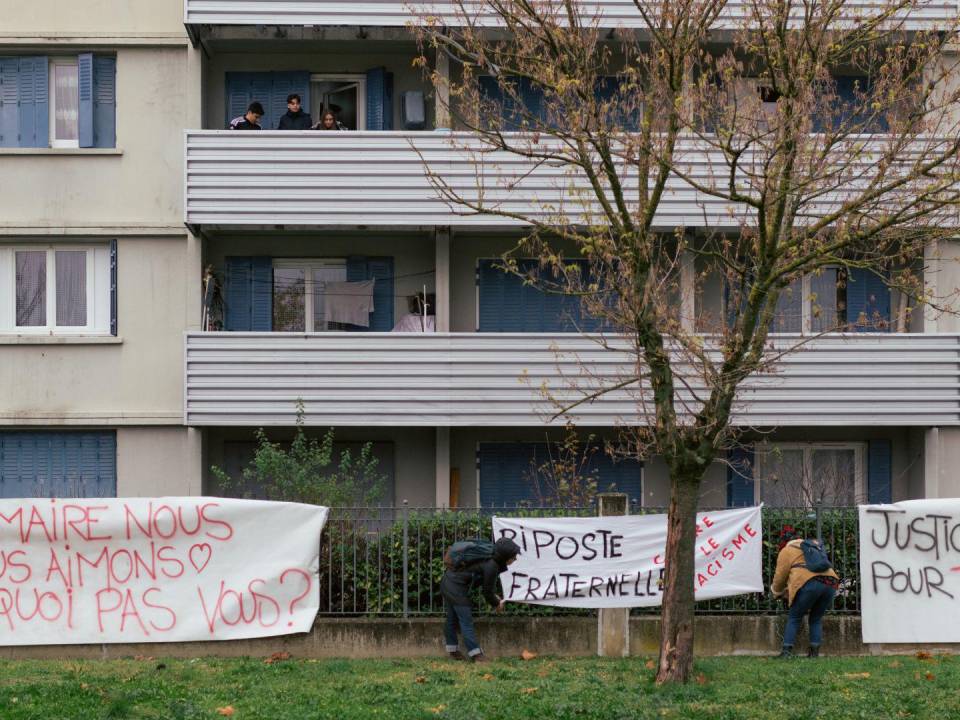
[{"xmin": 0, "ymin": 243, "xmax": 111, "ymax": 337}]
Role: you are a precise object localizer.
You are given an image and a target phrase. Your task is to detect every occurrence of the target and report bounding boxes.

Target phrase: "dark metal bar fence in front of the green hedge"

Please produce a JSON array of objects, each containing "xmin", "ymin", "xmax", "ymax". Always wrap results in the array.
[{"xmin": 320, "ymin": 507, "xmax": 860, "ymax": 616}]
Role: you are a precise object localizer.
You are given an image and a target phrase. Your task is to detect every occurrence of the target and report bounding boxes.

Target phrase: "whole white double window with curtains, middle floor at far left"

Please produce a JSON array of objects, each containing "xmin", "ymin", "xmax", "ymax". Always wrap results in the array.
[{"xmin": 0, "ymin": 245, "xmax": 111, "ymax": 335}]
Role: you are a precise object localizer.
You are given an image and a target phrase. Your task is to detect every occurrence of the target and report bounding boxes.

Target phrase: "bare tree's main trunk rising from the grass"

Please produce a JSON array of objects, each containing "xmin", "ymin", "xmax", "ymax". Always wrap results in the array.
[{"xmin": 657, "ymin": 473, "xmax": 700, "ymax": 685}]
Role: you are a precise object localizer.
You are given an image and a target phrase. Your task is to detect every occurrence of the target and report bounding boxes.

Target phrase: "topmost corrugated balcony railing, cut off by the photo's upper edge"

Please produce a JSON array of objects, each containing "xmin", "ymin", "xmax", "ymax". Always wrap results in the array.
[{"xmin": 185, "ymin": 0, "xmax": 957, "ymax": 30}]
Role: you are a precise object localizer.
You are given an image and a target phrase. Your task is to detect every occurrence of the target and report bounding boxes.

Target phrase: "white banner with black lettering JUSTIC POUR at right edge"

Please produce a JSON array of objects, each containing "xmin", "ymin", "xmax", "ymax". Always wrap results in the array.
[{"xmin": 860, "ymin": 498, "xmax": 960, "ymax": 643}]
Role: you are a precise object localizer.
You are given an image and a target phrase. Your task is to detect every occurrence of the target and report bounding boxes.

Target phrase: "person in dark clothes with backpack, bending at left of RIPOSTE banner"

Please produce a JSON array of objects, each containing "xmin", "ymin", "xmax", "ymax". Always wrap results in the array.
[{"xmin": 440, "ymin": 538, "xmax": 520, "ymax": 662}]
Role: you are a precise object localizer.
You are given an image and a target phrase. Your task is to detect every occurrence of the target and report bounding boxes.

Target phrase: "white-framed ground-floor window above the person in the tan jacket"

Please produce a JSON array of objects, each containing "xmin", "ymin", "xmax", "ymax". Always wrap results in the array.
[{"xmin": 754, "ymin": 443, "xmax": 867, "ymax": 507}]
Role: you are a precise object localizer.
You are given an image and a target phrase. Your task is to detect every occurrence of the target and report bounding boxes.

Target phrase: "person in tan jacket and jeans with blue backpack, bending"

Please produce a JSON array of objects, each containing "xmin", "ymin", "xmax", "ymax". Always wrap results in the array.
[{"xmin": 771, "ymin": 525, "xmax": 840, "ymax": 658}]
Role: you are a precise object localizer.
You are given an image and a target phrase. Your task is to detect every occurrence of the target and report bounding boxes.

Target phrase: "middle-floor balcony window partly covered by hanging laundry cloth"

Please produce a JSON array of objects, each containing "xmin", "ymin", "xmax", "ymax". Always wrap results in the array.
[{"xmin": 273, "ymin": 259, "xmax": 347, "ymax": 332}]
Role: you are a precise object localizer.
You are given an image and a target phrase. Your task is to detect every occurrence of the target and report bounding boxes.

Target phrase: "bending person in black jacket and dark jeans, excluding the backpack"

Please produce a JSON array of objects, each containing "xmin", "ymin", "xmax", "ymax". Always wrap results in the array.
[{"xmin": 440, "ymin": 538, "xmax": 520, "ymax": 662}]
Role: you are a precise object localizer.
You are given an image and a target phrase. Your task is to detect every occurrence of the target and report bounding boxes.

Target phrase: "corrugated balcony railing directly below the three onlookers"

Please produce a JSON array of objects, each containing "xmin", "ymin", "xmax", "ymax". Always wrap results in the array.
[{"xmin": 184, "ymin": 130, "xmax": 949, "ymax": 229}]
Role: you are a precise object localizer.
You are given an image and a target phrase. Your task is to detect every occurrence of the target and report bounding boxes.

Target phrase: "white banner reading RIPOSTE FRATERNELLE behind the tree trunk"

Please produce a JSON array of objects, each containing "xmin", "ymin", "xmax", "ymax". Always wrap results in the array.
[{"xmin": 493, "ymin": 507, "xmax": 763, "ymax": 608}]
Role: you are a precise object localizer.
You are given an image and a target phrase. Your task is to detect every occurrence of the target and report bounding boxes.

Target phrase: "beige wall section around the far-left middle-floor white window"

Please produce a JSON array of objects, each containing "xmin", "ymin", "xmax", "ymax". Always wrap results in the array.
[{"xmin": 0, "ymin": 236, "xmax": 193, "ymax": 425}]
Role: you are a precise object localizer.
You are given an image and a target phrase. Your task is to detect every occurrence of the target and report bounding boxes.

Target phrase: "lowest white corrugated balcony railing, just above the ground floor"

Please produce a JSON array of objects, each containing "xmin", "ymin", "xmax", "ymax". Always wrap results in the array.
[{"xmin": 184, "ymin": 333, "xmax": 960, "ymax": 427}]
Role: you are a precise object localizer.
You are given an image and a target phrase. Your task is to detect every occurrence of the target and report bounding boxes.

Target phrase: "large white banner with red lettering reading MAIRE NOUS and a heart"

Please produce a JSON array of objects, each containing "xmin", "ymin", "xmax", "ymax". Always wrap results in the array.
[{"xmin": 0, "ymin": 497, "xmax": 327, "ymax": 645}]
